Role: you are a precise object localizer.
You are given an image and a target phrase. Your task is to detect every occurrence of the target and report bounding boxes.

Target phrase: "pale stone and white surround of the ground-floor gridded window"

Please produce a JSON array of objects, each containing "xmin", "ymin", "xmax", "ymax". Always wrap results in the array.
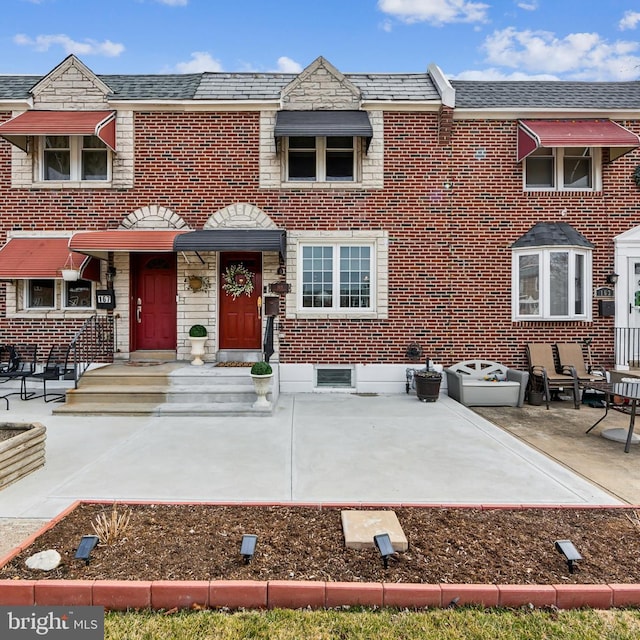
[{"xmin": 286, "ymin": 230, "xmax": 389, "ymax": 320}]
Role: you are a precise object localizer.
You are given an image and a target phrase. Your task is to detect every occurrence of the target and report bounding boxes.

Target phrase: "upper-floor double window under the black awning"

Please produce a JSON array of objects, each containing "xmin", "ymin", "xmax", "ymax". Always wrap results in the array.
[{"xmin": 285, "ymin": 136, "xmax": 357, "ymax": 182}]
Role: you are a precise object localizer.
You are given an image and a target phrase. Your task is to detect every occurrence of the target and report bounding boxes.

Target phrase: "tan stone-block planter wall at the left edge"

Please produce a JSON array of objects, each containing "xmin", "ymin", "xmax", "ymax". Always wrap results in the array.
[{"xmin": 0, "ymin": 422, "xmax": 47, "ymax": 489}]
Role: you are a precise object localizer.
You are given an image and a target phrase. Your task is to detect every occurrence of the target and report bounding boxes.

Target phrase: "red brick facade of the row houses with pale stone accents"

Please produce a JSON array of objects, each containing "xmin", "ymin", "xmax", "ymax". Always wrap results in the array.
[{"xmin": 0, "ymin": 55, "xmax": 640, "ymax": 389}]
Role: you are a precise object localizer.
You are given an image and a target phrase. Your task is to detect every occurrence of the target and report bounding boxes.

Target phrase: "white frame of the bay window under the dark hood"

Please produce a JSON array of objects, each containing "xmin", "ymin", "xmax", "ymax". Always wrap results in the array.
[{"xmin": 511, "ymin": 245, "xmax": 593, "ymax": 322}]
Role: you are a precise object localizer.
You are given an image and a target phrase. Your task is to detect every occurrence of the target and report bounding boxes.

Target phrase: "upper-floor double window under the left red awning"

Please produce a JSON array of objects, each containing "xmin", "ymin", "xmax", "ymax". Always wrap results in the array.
[{"xmin": 40, "ymin": 136, "xmax": 111, "ymax": 181}]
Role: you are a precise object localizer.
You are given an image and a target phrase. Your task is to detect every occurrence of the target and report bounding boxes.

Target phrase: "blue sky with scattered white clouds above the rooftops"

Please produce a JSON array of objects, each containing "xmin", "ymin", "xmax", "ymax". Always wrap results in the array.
[{"xmin": 0, "ymin": 0, "xmax": 640, "ymax": 81}]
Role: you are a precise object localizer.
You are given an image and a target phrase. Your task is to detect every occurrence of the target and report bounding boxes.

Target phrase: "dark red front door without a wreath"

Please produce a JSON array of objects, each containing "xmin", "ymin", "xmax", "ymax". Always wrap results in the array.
[{"xmin": 131, "ymin": 253, "xmax": 177, "ymax": 350}]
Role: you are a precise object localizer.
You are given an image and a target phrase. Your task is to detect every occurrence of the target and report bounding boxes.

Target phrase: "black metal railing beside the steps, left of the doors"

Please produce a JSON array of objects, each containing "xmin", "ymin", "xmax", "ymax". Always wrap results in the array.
[{"xmin": 68, "ymin": 314, "xmax": 115, "ymax": 389}]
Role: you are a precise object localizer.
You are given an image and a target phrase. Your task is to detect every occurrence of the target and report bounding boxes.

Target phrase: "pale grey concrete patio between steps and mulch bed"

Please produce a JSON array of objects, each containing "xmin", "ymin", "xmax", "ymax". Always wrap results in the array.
[{"xmin": 0, "ymin": 394, "xmax": 619, "ymax": 519}]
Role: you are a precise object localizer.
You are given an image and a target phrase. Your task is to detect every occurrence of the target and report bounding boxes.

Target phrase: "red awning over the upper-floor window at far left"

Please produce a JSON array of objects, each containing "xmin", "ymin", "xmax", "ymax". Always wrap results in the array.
[{"xmin": 0, "ymin": 109, "xmax": 116, "ymax": 151}]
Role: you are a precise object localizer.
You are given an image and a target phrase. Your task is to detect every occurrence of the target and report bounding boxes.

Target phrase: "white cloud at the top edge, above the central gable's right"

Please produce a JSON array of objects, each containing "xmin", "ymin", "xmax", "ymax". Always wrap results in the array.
[{"xmin": 378, "ymin": 0, "xmax": 489, "ymax": 26}]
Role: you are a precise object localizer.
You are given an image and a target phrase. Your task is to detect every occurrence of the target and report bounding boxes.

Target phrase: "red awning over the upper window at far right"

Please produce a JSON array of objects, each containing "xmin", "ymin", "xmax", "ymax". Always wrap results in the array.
[{"xmin": 518, "ymin": 120, "xmax": 640, "ymax": 162}]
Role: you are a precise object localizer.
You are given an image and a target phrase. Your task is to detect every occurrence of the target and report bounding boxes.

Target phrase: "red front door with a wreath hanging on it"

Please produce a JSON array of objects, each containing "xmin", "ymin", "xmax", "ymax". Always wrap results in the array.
[{"xmin": 220, "ymin": 253, "xmax": 262, "ymax": 349}]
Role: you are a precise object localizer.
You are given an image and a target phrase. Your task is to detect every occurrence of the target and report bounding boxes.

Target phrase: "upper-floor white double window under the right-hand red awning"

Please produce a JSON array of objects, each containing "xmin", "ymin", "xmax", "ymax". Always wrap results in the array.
[{"xmin": 524, "ymin": 147, "xmax": 600, "ymax": 191}]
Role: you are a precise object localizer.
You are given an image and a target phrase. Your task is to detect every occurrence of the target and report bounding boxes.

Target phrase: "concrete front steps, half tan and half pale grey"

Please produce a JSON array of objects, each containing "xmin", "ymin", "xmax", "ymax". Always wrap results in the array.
[{"xmin": 53, "ymin": 361, "xmax": 277, "ymax": 416}]
